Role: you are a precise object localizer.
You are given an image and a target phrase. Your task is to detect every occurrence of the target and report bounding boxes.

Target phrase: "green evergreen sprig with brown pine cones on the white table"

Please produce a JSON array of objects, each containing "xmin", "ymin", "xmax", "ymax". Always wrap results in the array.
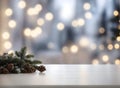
[{"xmin": 0, "ymin": 47, "xmax": 46, "ymax": 74}]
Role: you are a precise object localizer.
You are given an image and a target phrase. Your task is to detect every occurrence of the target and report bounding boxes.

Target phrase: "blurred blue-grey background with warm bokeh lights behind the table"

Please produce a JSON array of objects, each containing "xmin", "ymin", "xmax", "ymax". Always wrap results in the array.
[{"xmin": 0, "ymin": 0, "xmax": 120, "ymax": 64}]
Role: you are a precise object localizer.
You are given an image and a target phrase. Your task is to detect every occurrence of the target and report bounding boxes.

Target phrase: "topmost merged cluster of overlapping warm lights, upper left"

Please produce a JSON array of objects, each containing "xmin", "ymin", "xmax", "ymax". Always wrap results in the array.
[{"xmin": 27, "ymin": 4, "xmax": 42, "ymax": 16}]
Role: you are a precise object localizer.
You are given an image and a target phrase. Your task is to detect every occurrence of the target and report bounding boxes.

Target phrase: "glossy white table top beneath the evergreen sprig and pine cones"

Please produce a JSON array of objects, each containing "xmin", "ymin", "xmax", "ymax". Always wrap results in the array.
[{"xmin": 0, "ymin": 65, "xmax": 120, "ymax": 88}]
